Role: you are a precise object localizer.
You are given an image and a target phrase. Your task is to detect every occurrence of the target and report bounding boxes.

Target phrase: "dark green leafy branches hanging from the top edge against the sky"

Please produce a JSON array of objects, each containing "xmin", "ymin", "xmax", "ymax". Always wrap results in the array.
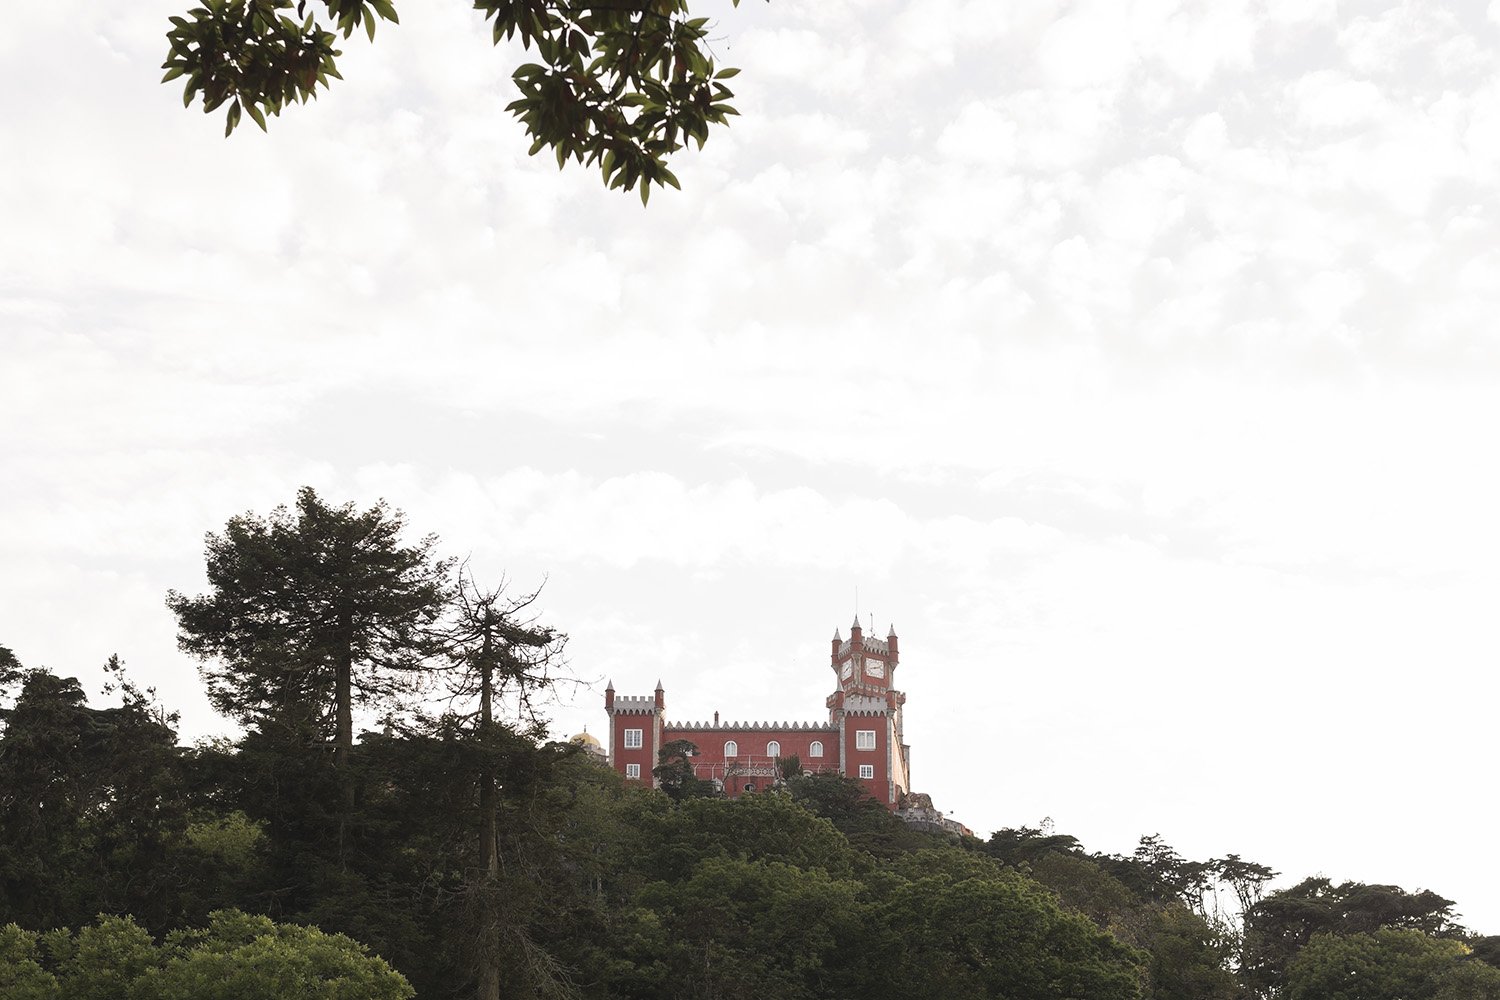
[{"xmin": 162, "ymin": 0, "xmax": 740, "ymax": 204}]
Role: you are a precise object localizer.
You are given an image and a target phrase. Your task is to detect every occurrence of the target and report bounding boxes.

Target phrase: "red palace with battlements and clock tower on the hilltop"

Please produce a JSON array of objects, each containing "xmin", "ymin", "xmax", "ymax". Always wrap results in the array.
[{"xmin": 605, "ymin": 618, "xmax": 906, "ymax": 810}]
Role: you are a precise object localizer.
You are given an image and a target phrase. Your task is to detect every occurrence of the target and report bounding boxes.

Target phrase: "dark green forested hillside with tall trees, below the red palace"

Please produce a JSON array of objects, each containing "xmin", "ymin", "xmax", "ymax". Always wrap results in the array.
[{"xmin": 0, "ymin": 490, "xmax": 1500, "ymax": 1000}]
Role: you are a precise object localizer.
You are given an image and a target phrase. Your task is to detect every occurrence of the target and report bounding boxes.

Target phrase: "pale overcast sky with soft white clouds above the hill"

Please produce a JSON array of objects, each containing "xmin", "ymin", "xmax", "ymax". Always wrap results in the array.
[{"xmin": 0, "ymin": 0, "xmax": 1500, "ymax": 933}]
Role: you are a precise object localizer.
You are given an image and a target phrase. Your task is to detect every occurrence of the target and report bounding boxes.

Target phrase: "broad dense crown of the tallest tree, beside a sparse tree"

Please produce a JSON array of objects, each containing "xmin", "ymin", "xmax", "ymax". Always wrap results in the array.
[{"xmin": 167, "ymin": 487, "xmax": 450, "ymax": 766}]
